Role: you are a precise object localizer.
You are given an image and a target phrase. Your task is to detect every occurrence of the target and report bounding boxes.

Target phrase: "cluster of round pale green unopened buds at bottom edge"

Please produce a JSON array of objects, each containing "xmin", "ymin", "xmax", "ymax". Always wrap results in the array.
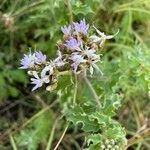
[{"xmin": 101, "ymin": 139, "xmax": 119, "ymax": 150}]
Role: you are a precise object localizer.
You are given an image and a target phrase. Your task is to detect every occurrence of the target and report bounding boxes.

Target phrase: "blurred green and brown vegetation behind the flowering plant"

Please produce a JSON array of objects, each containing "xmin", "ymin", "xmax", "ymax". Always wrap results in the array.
[{"xmin": 0, "ymin": 0, "xmax": 150, "ymax": 150}]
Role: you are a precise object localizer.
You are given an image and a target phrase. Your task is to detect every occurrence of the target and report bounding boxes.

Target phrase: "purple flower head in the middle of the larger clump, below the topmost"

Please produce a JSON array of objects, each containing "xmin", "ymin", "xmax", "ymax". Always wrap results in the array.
[{"xmin": 65, "ymin": 37, "xmax": 81, "ymax": 51}]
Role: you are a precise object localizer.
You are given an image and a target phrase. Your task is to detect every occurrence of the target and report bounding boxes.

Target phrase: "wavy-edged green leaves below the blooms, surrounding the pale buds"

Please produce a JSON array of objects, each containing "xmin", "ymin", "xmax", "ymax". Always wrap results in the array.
[{"xmin": 64, "ymin": 95, "xmax": 127, "ymax": 150}]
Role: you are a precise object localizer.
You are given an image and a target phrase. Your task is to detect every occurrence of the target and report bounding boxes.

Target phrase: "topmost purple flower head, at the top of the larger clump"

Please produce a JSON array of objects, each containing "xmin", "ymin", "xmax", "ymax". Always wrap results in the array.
[{"xmin": 74, "ymin": 19, "xmax": 89, "ymax": 35}]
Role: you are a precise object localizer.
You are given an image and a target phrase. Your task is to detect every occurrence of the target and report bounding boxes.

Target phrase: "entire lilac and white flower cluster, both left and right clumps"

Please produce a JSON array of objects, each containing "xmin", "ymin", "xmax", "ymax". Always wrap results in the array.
[{"xmin": 20, "ymin": 19, "xmax": 115, "ymax": 90}]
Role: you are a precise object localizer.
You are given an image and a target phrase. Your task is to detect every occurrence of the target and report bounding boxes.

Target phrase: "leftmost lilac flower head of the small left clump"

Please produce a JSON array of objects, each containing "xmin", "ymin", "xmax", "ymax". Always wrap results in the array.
[{"xmin": 20, "ymin": 53, "xmax": 36, "ymax": 69}]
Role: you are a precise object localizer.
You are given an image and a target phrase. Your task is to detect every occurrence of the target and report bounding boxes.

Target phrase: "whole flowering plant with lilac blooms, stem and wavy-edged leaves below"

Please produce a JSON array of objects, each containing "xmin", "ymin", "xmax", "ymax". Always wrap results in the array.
[{"xmin": 20, "ymin": 19, "xmax": 126, "ymax": 150}]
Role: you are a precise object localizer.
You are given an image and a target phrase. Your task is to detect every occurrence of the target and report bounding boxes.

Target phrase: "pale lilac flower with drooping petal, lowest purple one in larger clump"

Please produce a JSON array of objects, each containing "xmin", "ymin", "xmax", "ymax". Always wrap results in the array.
[{"xmin": 70, "ymin": 54, "xmax": 86, "ymax": 73}]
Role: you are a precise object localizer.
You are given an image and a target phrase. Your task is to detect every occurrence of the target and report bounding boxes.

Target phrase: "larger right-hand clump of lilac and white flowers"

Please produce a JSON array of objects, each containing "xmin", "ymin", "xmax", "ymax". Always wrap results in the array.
[{"xmin": 58, "ymin": 19, "xmax": 117, "ymax": 74}]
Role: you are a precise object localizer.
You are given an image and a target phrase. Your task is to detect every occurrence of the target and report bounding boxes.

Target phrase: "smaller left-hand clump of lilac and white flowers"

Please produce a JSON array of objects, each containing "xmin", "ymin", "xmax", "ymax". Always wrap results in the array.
[{"xmin": 20, "ymin": 51, "xmax": 58, "ymax": 91}]
